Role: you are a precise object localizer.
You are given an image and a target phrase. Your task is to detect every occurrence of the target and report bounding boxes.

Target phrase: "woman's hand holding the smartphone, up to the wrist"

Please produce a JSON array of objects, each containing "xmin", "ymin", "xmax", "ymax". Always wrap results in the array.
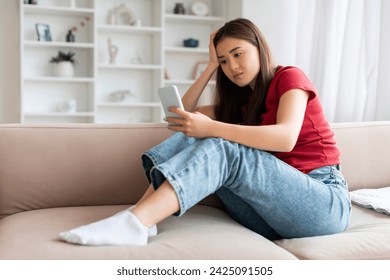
[{"xmin": 166, "ymin": 107, "xmax": 215, "ymax": 138}]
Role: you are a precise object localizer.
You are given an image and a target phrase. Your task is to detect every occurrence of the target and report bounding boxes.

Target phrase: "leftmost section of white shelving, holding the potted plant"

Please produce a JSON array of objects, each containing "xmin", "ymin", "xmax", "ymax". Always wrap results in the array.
[{"xmin": 20, "ymin": 0, "xmax": 96, "ymax": 123}]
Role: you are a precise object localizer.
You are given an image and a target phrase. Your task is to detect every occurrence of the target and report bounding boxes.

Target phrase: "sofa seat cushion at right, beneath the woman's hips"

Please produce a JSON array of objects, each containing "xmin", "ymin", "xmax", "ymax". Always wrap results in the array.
[{"xmin": 276, "ymin": 205, "xmax": 390, "ymax": 260}]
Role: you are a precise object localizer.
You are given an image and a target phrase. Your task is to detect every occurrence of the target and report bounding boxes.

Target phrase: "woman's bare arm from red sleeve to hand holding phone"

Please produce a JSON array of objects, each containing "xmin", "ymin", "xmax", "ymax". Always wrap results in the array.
[{"xmin": 167, "ymin": 89, "xmax": 309, "ymax": 152}]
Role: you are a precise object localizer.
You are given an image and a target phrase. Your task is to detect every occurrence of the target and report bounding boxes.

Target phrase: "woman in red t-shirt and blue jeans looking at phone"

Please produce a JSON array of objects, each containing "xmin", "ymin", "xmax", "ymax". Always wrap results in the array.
[{"xmin": 60, "ymin": 19, "xmax": 351, "ymax": 245}]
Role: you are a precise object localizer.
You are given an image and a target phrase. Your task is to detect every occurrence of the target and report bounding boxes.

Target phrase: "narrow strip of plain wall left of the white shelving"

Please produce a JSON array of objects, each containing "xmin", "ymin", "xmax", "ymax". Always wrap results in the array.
[{"xmin": 0, "ymin": 0, "xmax": 20, "ymax": 123}]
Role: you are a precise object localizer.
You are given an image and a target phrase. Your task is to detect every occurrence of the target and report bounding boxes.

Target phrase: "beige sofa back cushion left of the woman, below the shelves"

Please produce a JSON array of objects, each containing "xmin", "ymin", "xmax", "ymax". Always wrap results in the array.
[{"xmin": 0, "ymin": 124, "xmax": 171, "ymax": 218}]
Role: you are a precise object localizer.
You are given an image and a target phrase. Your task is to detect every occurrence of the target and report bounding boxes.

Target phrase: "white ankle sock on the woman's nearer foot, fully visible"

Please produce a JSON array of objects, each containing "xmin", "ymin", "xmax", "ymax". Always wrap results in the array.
[{"xmin": 60, "ymin": 211, "xmax": 148, "ymax": 245}]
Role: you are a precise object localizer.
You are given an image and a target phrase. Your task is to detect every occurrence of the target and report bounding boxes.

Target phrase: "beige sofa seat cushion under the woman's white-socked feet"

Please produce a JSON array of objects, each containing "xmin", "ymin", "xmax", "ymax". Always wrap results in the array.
[{"xmin": 0, "ymin": 205, "xmax": 296, "ymax": 260}]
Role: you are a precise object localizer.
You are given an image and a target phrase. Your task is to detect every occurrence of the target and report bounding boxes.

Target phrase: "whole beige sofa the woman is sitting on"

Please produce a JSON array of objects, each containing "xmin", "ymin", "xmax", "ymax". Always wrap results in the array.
[{"xmin": 0, "ymin": 122, "xmax": 390, "ymax": 259}]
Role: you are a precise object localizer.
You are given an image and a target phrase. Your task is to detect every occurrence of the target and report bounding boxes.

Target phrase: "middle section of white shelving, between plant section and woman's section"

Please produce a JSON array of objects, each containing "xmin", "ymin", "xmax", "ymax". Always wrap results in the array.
[{"xmin": 96, "ymin": 0, "xmax": 163, "ymax": 123}]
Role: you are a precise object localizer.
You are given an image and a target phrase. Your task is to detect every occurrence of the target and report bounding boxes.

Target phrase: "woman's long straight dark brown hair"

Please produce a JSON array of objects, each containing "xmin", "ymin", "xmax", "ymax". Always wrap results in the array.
[{"xmin": 214, "ymin": 18, "xmax": 275, "ymax": 125}]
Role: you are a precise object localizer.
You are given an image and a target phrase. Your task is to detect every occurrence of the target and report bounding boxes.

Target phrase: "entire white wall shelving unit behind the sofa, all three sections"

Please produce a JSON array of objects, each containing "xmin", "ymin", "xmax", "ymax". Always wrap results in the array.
[{"xmin": 20, "ymin": 0, "xmax": 236, "ymax": 123}]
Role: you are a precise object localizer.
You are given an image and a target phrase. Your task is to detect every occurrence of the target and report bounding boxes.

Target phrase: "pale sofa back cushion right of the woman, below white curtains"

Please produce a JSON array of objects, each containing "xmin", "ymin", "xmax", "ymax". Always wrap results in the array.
[{"xmin": 332, "ymin": 122, "xmax": 390, "ymax": 190}]
